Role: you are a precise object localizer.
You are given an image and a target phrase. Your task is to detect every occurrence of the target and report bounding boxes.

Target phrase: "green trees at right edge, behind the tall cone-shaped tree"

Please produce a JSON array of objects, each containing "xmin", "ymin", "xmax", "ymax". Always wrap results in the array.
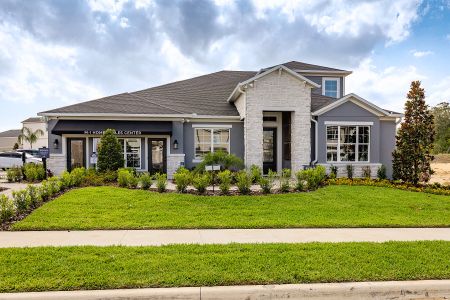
[{"xmin": 431, "ymin": 102, "xmax": 450, "ymax": 153}]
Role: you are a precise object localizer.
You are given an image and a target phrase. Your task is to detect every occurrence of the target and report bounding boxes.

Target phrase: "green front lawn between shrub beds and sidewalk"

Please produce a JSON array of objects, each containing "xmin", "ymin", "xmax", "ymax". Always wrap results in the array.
[{"xmin": 13, "ymin": 186, "xmax": 450, "ymax": 230}]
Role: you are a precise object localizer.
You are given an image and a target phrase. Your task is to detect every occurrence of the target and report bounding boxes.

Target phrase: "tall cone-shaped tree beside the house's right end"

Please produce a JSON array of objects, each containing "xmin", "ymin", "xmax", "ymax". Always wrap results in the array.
[{"xmin": 392, "ymin": 81, "xmax": 434, "ymax": 184}]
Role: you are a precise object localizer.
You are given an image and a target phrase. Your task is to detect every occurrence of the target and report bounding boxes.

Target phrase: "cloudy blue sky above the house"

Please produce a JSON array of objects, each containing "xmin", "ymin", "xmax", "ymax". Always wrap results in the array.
[{"xmin": 0, "ymin": 0, "xmax": 450, "ymax": 131}]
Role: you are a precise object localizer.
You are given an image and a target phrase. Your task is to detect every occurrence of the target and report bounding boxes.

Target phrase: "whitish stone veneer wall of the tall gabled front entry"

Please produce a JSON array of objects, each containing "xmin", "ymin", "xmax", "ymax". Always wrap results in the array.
[{"xmin": 244, "ymin": 71, "xmax": 311, "ymax": 172}]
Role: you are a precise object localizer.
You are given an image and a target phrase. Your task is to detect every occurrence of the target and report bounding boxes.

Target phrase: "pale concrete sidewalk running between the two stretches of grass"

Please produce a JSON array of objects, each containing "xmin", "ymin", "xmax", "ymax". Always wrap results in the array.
[{"xmin": 0, "ymin": 228, "xmax": 450, "ymax": 248}]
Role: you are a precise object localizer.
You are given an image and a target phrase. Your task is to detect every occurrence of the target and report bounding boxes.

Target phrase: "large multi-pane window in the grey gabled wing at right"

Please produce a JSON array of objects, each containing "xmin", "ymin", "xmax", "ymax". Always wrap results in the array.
[{"xmin": 327, "ymin": 126, "xmax": 370, "ymax": 162}]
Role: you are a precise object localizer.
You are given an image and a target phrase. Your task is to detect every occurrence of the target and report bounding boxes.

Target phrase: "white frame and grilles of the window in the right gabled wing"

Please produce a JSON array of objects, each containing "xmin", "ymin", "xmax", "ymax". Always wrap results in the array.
[{"xmin": 325, "ymin": 124, "xmax": 372, "ymax": 164}]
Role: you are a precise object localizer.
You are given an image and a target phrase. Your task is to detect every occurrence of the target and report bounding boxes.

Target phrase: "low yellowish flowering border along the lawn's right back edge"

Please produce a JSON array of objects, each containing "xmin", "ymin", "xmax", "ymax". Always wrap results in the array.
[{"xmin": 328, "ymin": 178, "xmax": 450, "ymax": 196}]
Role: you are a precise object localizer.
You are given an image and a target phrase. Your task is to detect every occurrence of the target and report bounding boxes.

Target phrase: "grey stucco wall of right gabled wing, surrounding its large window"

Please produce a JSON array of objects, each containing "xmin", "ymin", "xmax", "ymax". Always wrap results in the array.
[{"xmin": 318, "ymin": 102, "xmax": 396, "ymax": 177}]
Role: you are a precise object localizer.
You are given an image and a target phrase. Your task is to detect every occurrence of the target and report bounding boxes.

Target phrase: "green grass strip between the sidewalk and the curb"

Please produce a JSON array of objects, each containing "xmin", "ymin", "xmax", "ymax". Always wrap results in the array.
[{"xmin": 0, "ymin": 241, "xmax": 450, "ymax": 292}]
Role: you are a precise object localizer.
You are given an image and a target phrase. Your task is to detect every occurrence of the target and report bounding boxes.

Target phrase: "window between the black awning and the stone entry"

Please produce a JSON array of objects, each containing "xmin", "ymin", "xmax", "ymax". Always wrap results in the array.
[{"xmin": 194, "ymin": 128, "xmax": 230, "ymax": 159}]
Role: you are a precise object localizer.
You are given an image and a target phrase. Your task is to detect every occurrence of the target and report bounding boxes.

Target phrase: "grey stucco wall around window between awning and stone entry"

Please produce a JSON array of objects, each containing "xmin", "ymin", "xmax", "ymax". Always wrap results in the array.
[{"xmin": 183, "ymin": 122, "xmax": 244, "ymax": 169}]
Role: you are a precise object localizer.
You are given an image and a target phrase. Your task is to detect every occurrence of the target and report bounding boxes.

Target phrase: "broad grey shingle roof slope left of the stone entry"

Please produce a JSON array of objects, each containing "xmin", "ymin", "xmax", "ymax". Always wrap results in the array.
[{"xmin": 44, "ymin": 71, "xmax": 256, "ymax": 116}]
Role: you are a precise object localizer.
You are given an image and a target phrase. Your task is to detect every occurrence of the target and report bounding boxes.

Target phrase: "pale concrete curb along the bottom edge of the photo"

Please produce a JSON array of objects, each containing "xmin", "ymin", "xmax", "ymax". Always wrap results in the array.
[{"xmin": 0, "ymin": 280, "xmax": 450, "ymax": 300}]
